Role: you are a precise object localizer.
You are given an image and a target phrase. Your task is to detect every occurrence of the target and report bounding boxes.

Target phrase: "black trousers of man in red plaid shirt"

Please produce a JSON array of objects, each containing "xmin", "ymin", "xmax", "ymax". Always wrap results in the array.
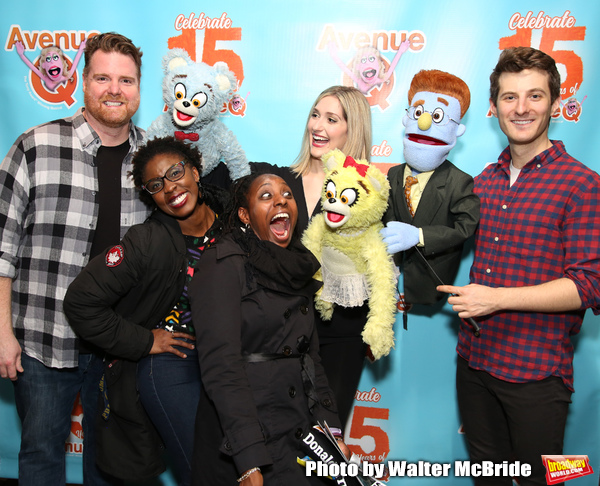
[{"xmin": 456, "ymin": 356, "xmax": 571, "ymax": 486}]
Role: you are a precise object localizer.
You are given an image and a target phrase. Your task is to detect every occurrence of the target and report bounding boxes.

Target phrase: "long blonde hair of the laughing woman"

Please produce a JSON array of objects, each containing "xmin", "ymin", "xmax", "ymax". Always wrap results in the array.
[{"xmin": 291, "ymin": 86, "xmax": 371, "ymax": 176}]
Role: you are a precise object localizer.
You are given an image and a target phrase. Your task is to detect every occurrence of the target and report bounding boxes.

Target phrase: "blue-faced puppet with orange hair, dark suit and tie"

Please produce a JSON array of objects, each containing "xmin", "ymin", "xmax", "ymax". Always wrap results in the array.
[{"xmin": 382, "ymin": 70, "xmax": 480, "ymax": 305}]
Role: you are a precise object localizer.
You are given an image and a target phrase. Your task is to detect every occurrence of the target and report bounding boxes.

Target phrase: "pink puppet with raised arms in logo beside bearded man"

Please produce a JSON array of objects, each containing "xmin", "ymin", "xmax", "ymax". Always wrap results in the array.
[{"xmin": 15, "ymin": 39, "xmax": 87, "ymax": 91}]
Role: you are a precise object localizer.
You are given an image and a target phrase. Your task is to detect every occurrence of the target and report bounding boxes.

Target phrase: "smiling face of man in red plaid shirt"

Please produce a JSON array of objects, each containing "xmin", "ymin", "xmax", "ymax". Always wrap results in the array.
[{"xmin": 490, "ymin": 69, "xmax": 560, "ymax": 155}]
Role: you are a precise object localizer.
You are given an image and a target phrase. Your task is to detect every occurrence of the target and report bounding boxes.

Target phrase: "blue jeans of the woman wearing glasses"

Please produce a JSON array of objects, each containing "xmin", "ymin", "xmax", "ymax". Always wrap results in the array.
[{"xmin": 137, "ymin": 342, "xmax": 202, "ymax": 486}]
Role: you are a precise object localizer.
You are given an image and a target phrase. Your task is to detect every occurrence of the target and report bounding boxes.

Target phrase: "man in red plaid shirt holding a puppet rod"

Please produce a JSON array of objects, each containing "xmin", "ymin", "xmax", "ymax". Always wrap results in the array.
[{"xmin": 438, "ymin": 47, "xmax": 600, "ymax": 486}]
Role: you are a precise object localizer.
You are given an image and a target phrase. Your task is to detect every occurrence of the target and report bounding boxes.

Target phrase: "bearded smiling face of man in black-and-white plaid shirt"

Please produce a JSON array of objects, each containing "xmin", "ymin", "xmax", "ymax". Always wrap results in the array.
[{"xmin": 83, "ymin": 50, "xmax": 140, "ymax": 128}]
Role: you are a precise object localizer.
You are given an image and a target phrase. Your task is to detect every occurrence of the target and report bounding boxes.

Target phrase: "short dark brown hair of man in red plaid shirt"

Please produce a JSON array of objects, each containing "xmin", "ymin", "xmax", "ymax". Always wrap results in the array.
[{"xmin": 490, "ymin": 46, "xmax": 560, "ymax": 105}]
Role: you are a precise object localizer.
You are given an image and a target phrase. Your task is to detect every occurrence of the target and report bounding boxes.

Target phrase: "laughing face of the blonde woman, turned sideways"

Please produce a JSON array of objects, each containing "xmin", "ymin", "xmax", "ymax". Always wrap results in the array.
[{"xmin": 306, "ymin": 96, "xmax": 348, "ymax": 163}]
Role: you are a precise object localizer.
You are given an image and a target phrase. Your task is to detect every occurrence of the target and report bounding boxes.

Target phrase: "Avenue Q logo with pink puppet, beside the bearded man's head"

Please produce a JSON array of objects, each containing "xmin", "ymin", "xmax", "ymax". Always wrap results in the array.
[{"xmin": 4, "ymin": 25, "xmax": 99, "ymax": 109}]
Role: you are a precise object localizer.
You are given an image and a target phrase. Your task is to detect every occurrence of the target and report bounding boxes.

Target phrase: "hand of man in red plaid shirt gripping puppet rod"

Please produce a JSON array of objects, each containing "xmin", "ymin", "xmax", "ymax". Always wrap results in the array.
[{"xmin": 437, "ymin": 284, "xmax": 501, "ymax": 319}]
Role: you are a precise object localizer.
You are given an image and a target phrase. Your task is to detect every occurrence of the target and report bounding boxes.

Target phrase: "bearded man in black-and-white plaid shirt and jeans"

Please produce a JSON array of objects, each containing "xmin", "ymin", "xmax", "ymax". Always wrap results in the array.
[{"xmin": 0, "ymin": 33, "xmax": 148, "ymax": 486}]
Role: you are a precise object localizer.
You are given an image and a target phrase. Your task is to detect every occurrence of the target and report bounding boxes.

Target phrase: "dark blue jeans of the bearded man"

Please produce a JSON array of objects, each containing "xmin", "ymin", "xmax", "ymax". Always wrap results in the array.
[{"xmin": 14, "ymin": 353, "xmax": 114, "ymax": 486}]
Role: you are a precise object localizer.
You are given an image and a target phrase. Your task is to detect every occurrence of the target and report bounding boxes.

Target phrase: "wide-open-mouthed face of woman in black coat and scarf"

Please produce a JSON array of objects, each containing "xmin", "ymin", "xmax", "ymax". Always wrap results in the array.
[{"xmin": 238, "ymin": 174, "xmax": 298, "ymax": 248}]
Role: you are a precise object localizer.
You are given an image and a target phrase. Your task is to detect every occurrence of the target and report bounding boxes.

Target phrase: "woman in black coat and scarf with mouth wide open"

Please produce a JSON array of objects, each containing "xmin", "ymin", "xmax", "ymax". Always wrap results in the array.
[{"xmin": 190, "ymin": 174, "xmax": 341, "ymax": 485}]
